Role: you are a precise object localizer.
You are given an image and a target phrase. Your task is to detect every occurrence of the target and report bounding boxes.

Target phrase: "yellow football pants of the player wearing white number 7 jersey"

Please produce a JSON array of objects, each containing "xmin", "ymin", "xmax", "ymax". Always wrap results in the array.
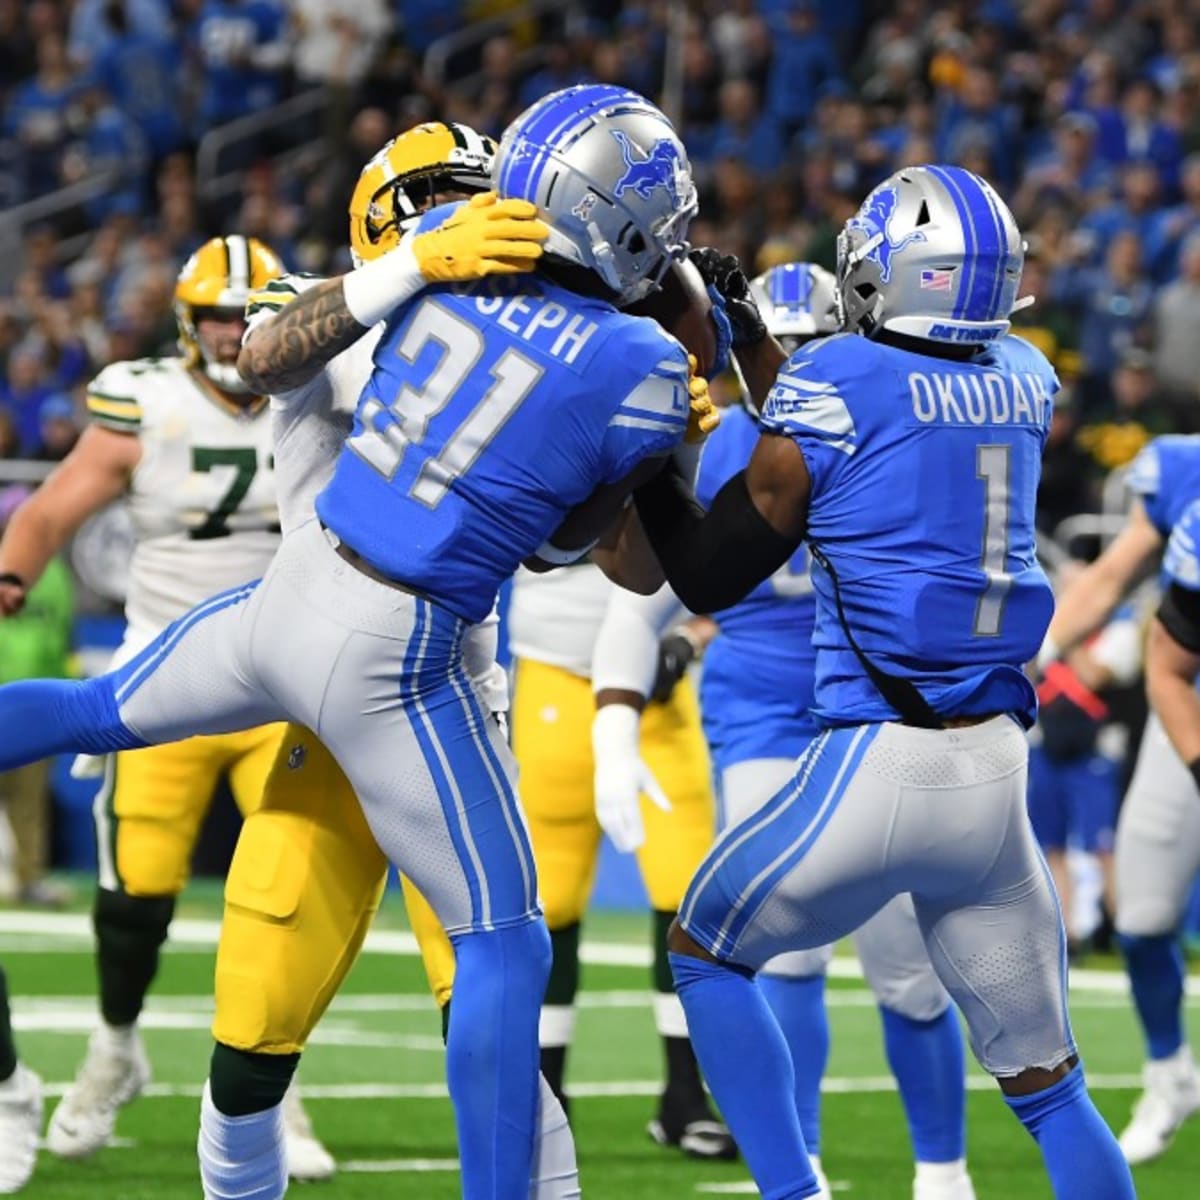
[{"xmin": 94, "ymin": 725, "xmax": 283, "ymax": 896}]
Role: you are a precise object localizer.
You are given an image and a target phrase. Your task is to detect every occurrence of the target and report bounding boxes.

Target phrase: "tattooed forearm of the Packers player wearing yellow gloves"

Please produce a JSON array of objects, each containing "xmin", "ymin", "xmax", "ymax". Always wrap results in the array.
[{"xmin": 238, "ymin": 276, "xmax": 364, "ymax": 396}]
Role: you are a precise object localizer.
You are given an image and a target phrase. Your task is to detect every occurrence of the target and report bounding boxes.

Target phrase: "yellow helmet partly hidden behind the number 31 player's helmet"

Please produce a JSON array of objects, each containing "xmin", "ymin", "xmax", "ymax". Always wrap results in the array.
[{"xmin": 350, "ymin": 121, "xmax": 496, "ymax": 265}]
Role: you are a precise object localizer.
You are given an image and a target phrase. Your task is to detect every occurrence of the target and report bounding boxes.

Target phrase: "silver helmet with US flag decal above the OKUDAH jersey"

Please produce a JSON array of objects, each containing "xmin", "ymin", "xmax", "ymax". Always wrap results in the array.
[{"xmin": 838, "ymin": 166, "xmax": 1025, "ymax": 346}]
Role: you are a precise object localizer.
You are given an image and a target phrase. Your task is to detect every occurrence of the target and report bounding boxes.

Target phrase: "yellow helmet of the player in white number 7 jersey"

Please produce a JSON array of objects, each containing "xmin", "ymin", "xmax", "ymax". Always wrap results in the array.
[{"xmin": 175, "ymin": 234, "xmax": 283, "ymax": 391}]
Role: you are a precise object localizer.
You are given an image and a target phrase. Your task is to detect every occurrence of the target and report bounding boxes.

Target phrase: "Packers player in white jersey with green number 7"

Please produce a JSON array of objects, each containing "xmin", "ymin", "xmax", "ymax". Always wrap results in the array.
[{"xmin": 0, "ymin": 236, "xmax": 334, "ymax": 1178}]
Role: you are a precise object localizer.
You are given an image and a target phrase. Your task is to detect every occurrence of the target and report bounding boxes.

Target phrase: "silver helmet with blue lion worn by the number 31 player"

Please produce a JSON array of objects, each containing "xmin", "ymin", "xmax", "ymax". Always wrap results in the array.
[{"xmin": 492, "ymin": 84, "xmax": 697, "ymax": 305}]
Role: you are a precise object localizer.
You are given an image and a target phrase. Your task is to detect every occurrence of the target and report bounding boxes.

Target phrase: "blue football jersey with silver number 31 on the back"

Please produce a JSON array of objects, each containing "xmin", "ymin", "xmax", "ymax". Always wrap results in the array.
[{"xmin": 317, "ymin": 262, "xmax": 689, "ymax": 622}]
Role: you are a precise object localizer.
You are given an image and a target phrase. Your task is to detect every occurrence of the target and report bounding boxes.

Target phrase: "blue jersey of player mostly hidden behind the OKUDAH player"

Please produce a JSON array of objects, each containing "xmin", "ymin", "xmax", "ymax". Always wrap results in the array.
[{"xmin": 696, "ymin": 407, "xmax": 817, "ymax": 770}]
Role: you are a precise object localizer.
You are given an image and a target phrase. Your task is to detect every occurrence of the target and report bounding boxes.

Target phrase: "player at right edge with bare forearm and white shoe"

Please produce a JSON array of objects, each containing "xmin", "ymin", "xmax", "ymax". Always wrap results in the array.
[{"xmin": 1038, "ymin": 436, "xmax": 1200, "ymax": 1164}]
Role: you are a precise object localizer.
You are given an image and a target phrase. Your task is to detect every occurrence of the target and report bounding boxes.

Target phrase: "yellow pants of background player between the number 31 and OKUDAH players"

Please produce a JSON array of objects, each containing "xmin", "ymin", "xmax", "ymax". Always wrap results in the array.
[{"xmin": 512, "ymin": 659, "xmax": 714, "ymax": 930}]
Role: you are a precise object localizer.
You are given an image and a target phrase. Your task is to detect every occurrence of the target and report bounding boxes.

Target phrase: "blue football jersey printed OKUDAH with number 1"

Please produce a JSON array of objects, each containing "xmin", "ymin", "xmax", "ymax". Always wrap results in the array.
[{"xmin": 762, "ymin": 335, "xmax": 1058, "ymax": 725}]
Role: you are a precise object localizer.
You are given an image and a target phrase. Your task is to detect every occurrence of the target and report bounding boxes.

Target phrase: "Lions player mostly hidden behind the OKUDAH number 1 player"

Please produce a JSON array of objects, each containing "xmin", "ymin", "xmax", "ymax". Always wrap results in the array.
[{"xmin": 695, "ymin": 263, "xmax": 974, "ymax": 1200}]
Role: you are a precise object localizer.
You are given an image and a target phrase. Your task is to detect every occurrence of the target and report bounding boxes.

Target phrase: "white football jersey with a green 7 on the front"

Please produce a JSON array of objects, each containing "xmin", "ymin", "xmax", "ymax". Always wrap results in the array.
[{"xmin": 88, "ymin": 358, "xmax": 280, "ymax": 659}]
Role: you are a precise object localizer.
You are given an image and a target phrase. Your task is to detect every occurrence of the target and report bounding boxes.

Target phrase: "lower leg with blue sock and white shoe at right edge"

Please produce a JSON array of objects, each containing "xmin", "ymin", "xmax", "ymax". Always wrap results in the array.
[{"xmin": 1115, "ymin": 716, "xmax": 1200, "ymax": 1163}]
